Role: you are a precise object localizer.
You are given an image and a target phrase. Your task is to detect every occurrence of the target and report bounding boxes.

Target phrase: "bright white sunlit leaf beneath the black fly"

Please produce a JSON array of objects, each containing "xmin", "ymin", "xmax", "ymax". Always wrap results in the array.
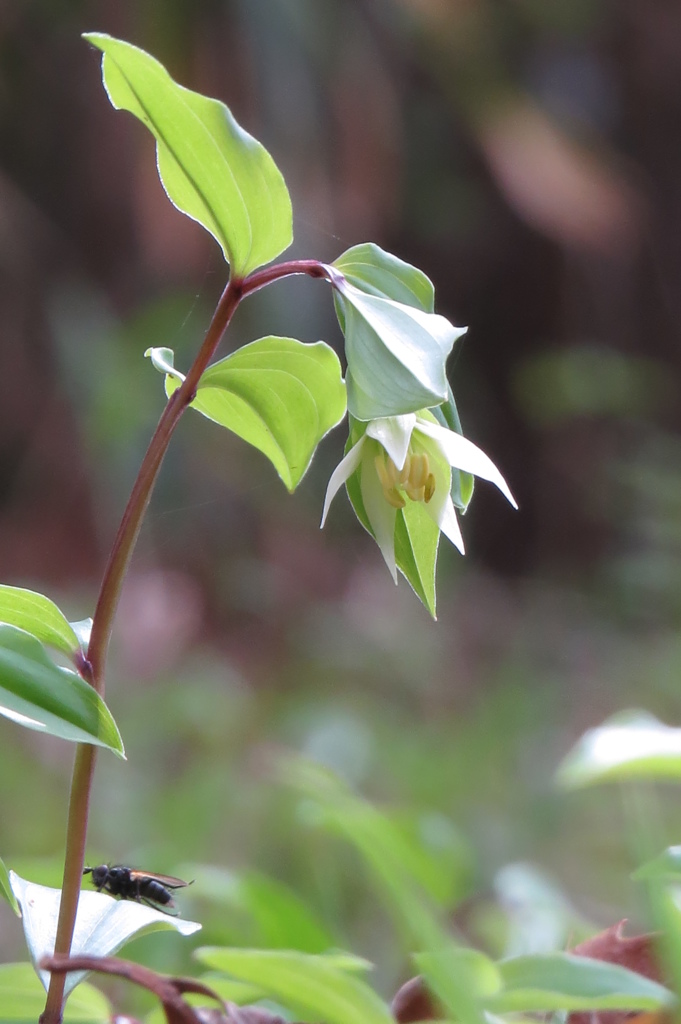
[{"xmin": 9, "ymin": 871, "xmax": 201, "ymax": 992}]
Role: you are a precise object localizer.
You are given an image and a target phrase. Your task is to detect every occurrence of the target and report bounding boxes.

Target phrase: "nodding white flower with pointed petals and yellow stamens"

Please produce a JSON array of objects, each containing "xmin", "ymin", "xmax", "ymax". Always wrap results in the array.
[{"xmin": 322, "ymin": 411, "xmax": 517, "ymax": 583}]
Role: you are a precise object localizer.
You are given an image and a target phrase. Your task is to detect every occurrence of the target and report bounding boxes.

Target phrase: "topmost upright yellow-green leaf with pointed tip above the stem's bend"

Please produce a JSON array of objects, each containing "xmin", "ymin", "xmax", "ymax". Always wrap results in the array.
[{"xmin": 84, "ymin": 32, "xmax": 293, "ymax": 276}]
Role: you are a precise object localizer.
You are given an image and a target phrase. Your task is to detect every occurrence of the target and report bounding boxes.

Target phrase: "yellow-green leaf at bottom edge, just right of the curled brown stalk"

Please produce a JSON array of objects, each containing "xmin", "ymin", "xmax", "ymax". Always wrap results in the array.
[{"xmin": 196, "ymin": 946, "xmax": 394, "ymax": 1024}]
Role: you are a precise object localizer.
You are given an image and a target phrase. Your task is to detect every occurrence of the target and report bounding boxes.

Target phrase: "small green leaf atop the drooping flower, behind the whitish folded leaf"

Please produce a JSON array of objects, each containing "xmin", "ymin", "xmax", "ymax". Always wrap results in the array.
[{"xmin": 333, "ymin": 242, "xmax": 435, "ymax": 313}]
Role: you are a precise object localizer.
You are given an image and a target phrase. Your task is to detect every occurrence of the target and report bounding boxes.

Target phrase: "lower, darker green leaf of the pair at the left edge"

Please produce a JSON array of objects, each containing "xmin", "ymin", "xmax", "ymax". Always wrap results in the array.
[{"xmin": 0, "ymin": 625, "xmax": 125, "ymax": 757}]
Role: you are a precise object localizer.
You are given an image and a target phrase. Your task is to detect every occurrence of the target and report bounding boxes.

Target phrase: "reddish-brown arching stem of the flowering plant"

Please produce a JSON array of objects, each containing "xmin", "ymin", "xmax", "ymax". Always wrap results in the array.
[{"xmin": 40, "ymin": 260, "xmax": 330, "ymax": 1024}]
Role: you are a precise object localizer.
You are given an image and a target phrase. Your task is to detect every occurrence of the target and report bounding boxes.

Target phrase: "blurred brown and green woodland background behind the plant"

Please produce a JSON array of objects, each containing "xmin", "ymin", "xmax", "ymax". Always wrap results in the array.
[{"xmin": 0, "ymin": 0, "xmax": 681, "ymax": 1015}]
